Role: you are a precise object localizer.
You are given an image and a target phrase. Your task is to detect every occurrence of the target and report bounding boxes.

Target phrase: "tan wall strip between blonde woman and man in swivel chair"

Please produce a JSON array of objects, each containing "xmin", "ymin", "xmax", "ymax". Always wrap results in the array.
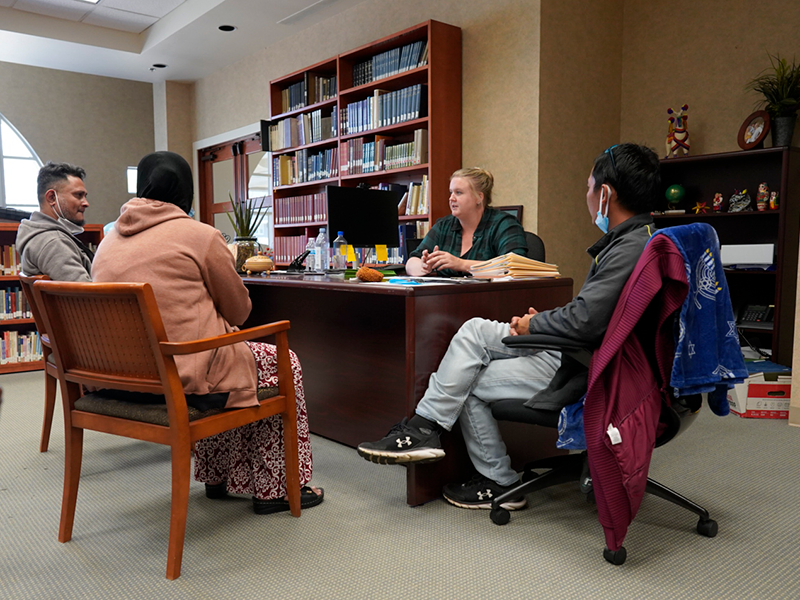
[{"xmin": 538, "ymin": 0, "xmax": 622, "ymax": 291}]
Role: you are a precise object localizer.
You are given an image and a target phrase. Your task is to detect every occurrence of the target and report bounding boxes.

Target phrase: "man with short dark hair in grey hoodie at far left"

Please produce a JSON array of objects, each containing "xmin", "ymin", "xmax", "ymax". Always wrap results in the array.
[{"xmin": 17, "ymin": 162, "xmax": 94, "ymax": 281}]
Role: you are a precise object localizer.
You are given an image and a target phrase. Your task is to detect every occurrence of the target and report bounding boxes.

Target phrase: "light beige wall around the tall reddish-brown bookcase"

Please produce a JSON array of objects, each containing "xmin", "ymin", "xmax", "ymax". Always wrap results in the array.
[{"xmin": 196, "ymin": 0, "xmax": 540, "ymax": 237}]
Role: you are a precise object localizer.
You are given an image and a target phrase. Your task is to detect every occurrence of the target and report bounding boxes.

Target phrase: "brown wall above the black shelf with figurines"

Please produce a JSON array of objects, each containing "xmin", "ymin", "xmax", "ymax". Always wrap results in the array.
[{"xmin": 620, "ymin": 0, "xmax": 800, "ymax": 156}]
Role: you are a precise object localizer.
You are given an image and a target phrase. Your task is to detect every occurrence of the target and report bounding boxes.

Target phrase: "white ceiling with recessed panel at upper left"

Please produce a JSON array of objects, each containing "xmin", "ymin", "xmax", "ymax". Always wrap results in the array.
[{"xmin": 0, "ymin": 0, "xmax": 372, "ymax": 82}]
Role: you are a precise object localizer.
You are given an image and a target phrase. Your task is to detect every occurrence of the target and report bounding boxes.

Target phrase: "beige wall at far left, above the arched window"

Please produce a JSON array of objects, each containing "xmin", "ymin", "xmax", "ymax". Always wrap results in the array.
[{"xmin": 0, "ymin": 62, "xmax": 153, "ymax": 223}]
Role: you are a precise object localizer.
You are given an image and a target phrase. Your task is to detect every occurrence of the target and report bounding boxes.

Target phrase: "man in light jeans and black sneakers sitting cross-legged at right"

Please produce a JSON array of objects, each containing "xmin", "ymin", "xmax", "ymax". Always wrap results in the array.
[{"xmin": 358, "ymin": 144, "xmax": 662, "ymax": 510}]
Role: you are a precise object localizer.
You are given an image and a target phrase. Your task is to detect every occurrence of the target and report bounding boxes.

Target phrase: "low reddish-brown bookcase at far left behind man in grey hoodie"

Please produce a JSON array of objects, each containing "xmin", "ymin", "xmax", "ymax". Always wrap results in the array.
[{"xmin": 0, "ymin": 223, "xmax": 103, "ymax": 375}]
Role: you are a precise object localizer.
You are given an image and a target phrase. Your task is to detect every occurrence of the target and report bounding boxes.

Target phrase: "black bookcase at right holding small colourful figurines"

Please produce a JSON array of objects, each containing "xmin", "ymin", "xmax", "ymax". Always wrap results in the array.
[{"xmin": 655, "ymin": 147, "xmax": 800, "ymax": 366}]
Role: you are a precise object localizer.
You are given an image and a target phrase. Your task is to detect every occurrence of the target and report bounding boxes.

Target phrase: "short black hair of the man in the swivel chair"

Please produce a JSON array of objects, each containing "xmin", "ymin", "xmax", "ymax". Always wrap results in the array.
[{"xmin": 592, "ymin": 144, "xmax": 663, "ymax": 215}]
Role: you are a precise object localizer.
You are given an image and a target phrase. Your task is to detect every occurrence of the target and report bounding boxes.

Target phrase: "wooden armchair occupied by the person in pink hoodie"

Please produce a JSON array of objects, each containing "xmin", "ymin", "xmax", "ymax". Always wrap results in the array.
[{"xmin": 33, "ymin": 281, "xmax": 300, "ymax": 579}]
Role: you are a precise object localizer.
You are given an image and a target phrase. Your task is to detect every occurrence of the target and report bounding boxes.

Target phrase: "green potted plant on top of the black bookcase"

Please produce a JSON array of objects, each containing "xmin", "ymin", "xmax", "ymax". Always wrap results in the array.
[{"xmin": 747, "ymin": 54, "xmax": 800, "ymax": 146}]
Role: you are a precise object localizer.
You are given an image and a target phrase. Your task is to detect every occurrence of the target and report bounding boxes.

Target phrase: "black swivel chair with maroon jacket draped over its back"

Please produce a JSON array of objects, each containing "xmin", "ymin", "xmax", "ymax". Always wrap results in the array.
[{"xmin": 490, "ymin": 227, "xmax": 718, "ymax": 565}]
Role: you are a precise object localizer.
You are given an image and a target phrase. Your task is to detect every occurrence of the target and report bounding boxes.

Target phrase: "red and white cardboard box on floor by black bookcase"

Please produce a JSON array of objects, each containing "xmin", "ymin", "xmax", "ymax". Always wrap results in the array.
[{"xmin": 728, "ymin": 373, "xmax": 792, "ymax": 419}]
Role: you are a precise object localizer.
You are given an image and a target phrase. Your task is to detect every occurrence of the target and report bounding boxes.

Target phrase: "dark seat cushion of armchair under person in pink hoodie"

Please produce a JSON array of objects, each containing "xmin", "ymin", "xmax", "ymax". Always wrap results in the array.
[{"xmin": 75, "ymin": 387, "xmax": 278, "ymax": 427}]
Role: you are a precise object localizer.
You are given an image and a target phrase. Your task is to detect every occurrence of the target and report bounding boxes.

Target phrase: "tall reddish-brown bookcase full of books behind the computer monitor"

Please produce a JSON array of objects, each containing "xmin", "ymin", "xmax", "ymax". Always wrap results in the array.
[{"xmin": 262, "ymin": 21, "xmax": 461, "ymax": 265}]
